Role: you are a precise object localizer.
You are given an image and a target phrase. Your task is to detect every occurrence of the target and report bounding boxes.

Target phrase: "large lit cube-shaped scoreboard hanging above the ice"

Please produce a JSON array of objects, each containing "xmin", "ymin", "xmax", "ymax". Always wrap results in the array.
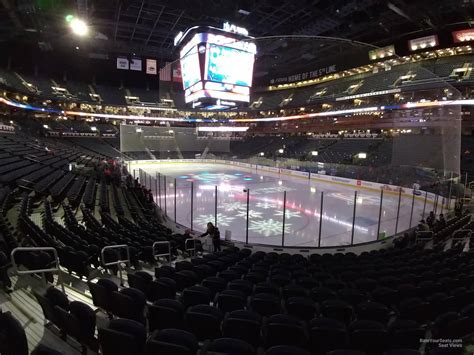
[{"xmin": 175, "ymin": 24, "xmax": 257, "ymax": 109}]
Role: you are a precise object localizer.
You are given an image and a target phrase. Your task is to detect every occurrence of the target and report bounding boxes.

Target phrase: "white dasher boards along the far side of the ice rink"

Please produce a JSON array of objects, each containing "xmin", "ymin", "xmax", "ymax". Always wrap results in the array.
[{"xmin": 127, "ymin": 159, "xmax": 448, "ymax": 206}]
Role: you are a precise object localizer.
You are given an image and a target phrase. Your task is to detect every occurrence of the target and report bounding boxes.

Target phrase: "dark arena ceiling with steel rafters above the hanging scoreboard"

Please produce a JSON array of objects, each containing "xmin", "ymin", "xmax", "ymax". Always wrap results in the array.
[{"xmin": 0, "ymin": 0, "xmax": 474, "ymax": 60}]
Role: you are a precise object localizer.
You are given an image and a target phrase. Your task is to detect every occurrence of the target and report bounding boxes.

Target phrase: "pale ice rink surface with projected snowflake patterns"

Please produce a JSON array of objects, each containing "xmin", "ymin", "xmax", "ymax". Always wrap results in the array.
[{"xmin": 133, "ymin": 162, "xmax": 432, "ymax": 247}]
